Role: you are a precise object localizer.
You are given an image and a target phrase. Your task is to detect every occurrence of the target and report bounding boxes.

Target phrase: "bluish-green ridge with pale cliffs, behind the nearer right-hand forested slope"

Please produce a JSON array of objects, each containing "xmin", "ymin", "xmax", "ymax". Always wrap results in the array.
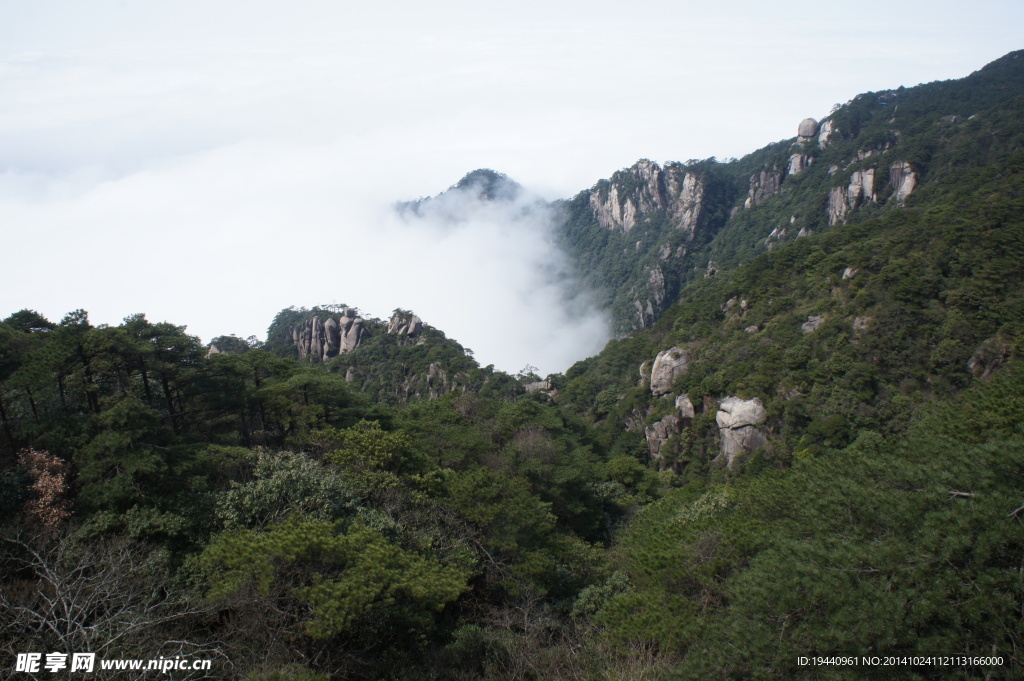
[{"xmin": 562, "ymin": 47, "xmax": 1024, "ymax": 332}]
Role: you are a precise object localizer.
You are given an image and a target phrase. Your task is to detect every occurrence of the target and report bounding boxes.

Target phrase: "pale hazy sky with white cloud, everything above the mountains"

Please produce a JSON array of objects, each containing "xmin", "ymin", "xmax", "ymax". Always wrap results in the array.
[{"xmin": 0, "ymin": 0, "xmax": 1024, "ymax": 375}]
